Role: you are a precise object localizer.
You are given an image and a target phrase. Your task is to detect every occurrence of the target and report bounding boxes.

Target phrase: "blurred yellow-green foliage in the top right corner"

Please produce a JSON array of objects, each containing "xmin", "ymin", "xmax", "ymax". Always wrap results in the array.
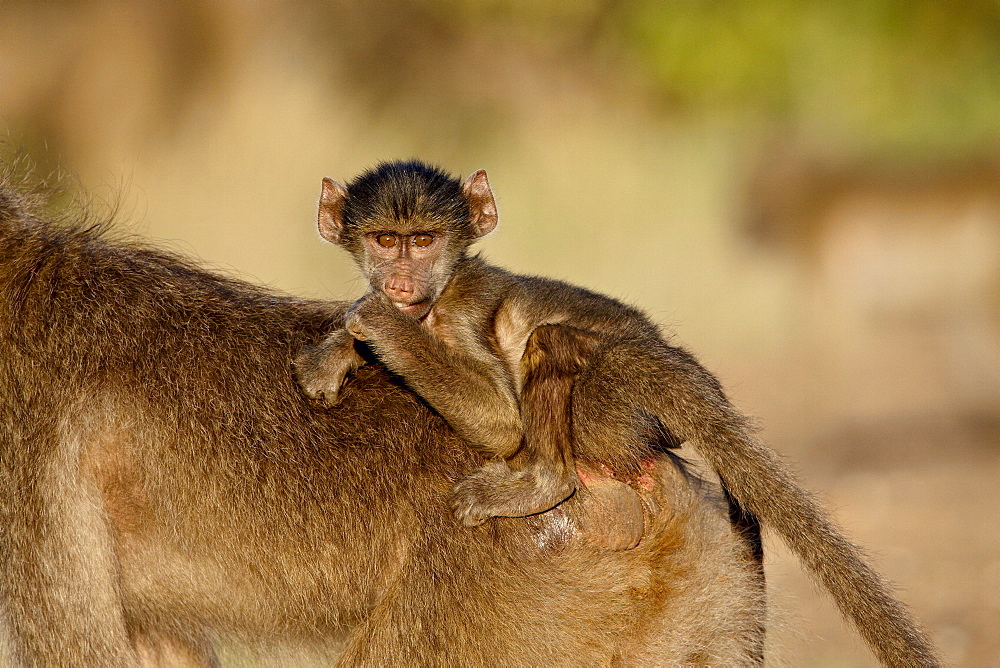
[{"xmin": 609, "ymin": 0, "xmax": 1000, "ymax": 152}]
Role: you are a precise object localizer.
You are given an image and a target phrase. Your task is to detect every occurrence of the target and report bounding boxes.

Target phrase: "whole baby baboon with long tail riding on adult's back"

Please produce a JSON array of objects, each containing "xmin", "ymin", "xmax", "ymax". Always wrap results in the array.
[{"xmin": 295, "ymin": 162, "xmax": 936, "ymax": 665}]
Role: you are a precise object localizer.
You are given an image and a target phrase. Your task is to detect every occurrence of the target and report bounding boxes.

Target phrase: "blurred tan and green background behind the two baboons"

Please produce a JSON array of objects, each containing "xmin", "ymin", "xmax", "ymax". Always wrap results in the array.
[{"xmin": 0, "ymin": 0, "xmax": 1000, "ymax": 666}]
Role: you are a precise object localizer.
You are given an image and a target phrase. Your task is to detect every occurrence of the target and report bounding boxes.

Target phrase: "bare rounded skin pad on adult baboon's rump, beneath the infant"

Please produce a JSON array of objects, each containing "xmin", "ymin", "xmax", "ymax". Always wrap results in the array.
[{"xmin": 574, "ymin": 471, "xmax": 646, "ymax": 552}]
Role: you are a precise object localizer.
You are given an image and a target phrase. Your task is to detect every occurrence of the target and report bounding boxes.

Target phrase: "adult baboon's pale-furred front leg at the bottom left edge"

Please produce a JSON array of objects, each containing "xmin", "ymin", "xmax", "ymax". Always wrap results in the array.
[{"xmin": 0, "ymin": 414, "xmax": 137, "ymax": 666}]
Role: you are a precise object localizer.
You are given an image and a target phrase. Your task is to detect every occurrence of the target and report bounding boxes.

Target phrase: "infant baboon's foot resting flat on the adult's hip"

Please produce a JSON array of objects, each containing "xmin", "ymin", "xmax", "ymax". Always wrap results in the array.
[{"xmin": 451, "ymin": 462, "xmax": 577, "ymax": 527}]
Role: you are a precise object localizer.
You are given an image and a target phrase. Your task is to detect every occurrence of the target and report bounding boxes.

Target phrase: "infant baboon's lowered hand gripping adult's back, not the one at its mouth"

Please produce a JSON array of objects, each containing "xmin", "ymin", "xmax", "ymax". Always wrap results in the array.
[{"xmin": 292, "ymin": 329, "xmax": 365, "ymax": 406}]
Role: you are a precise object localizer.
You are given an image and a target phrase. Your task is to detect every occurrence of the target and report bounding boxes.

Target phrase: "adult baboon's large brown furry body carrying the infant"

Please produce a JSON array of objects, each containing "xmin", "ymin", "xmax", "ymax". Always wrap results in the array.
[{"xmin": 0, "ymin": 172, "xmax": 763, "ymax": 666}]
